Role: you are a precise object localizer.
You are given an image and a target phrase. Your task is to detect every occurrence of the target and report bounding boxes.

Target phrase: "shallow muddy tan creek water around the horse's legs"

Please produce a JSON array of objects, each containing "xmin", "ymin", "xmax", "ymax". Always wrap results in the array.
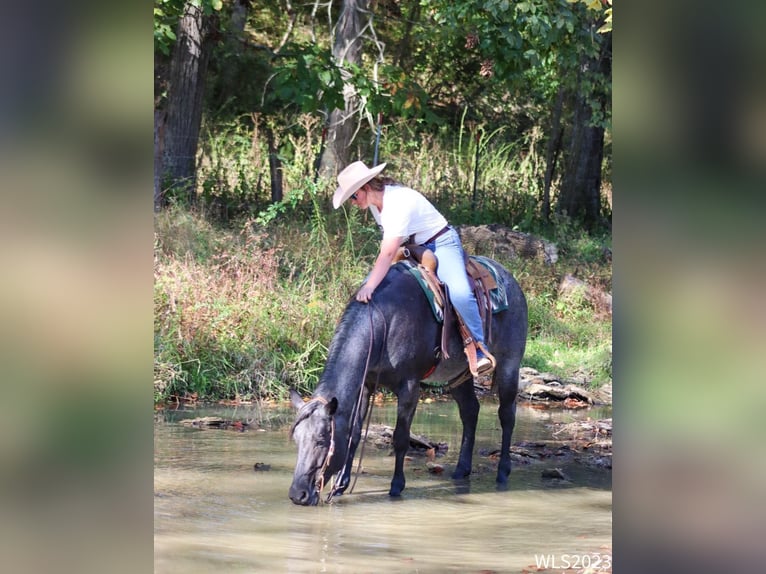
[{"xmin": 154, "ymin": 402, "xmax": 612, "ymax": 574}]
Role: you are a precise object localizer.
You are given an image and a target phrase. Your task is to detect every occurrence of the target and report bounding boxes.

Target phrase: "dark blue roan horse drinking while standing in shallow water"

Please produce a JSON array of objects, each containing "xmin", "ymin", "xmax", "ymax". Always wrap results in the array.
[{"xmin": 290, "ymin": 258, "xmax": 527, "ymax": 506}]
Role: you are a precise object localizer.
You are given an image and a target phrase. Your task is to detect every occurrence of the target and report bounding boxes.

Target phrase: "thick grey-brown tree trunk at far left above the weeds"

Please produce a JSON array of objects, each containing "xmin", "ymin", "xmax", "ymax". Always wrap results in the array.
[{"xmin": 162, "ymin": 1, "xmax": 211, "ymax": 203}]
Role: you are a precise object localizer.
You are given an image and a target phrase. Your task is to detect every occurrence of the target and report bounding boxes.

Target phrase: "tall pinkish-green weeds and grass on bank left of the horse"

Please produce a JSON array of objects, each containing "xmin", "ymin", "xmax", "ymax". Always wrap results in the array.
[{"xmin": 154, "ymin": 181, "xmax": 376, "ymax": 400}]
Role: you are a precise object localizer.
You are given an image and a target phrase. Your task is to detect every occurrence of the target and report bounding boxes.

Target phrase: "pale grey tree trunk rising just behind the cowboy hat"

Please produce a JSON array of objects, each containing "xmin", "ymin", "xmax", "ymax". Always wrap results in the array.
[{"xmin": 321, "ymin": 0, "xmax": 369, "ymax": 175}]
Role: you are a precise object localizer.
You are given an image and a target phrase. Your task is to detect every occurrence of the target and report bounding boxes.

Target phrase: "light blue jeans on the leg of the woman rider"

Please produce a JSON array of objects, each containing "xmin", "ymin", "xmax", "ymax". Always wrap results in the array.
[{"xmin": 424, "ymin": 228, "xmax": 484, "ymax": 343}]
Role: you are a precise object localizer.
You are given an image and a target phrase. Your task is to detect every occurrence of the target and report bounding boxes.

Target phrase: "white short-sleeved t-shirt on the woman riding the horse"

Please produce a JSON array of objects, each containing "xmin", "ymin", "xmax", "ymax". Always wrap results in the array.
[{"xmin": 370, "ymin": 185, "xmax": 447, "ymax": 243}]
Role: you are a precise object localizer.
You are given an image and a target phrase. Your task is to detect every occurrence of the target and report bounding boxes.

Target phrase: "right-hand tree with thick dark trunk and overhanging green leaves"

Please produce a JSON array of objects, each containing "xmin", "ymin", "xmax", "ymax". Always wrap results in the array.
[{"xmin": 412, "ymin": 0, "xmax": 611, "ymax": 230}]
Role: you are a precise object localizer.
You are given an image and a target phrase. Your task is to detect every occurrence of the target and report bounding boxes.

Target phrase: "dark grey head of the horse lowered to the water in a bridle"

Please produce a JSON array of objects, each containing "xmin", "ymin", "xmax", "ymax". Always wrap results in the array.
[{"xmin": 290, "ymin": 390, "xmax": 338, "ymax": 506}]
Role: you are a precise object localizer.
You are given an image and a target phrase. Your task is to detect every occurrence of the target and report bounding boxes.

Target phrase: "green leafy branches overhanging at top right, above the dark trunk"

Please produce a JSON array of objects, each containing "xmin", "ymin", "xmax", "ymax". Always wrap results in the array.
[{"xmin": 414, "ymin": 0, "xmax": 611, "ymax": 130}]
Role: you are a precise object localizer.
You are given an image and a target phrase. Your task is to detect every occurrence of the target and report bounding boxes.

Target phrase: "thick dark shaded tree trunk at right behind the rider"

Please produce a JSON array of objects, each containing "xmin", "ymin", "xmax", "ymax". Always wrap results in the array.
[{"xmin": 557, "ymin": 34, "xmax": 612, "ymax": 229}]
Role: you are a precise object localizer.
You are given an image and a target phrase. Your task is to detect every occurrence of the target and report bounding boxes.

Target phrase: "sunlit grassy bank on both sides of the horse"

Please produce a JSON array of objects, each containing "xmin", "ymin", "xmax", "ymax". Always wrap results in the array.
[{"xmin": 154, "ymin": 208, "xmax": 611, "ymax": 401}]
